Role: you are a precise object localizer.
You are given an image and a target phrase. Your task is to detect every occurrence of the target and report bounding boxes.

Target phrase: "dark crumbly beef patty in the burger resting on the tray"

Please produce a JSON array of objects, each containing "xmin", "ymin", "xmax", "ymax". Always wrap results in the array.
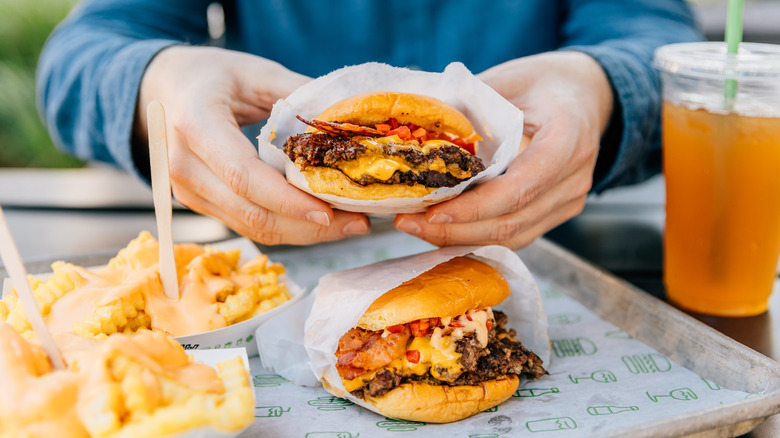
[{"xmin": 352, "ymin": 310, "xmax": 547, "ymax": 399}]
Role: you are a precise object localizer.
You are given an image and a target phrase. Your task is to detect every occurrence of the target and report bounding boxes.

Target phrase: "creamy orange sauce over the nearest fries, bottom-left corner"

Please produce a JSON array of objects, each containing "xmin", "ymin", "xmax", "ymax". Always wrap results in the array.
[{"xmin": 0, "ymin": 322, "xmax": 225, "ymax": 438}]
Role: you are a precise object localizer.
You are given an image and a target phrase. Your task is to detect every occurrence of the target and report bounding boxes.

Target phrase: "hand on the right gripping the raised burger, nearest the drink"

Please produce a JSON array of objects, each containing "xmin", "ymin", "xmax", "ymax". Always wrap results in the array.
[{"xmin": 395, "ymin": 52, "xmax": 613, "ymax": 249}]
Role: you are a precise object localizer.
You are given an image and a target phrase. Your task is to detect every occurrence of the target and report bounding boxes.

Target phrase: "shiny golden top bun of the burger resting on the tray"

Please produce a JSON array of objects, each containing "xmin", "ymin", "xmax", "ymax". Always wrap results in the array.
[{"xmin": 357, "ymin": 257, "xmax": 510, "ymax": 331}]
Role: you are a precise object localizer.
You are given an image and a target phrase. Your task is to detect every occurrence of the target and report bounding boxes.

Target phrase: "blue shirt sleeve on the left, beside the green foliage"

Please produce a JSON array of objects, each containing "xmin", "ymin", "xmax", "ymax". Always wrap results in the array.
[{"xmin": 36, "ymin": 0, "xmax": 210, "ymax": 175}]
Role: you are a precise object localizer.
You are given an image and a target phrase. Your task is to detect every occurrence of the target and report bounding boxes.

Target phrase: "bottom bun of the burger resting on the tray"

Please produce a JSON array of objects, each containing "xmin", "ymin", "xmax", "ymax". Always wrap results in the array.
[{"xmin": 366, "ymin": 375, "xmax": 520, "ymax": 423}]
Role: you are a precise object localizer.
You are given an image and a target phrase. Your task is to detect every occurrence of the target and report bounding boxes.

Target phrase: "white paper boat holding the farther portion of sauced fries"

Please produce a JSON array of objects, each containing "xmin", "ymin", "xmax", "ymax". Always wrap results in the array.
[{"xmin": 0, "ymin": 238, "xmax": 304, "ymax": 356}]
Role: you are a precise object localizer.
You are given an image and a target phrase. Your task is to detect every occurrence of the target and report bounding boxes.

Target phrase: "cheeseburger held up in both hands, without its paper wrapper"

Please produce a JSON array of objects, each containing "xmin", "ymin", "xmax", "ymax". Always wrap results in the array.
[{"xmin": 284, "ymin": 91, "xmax": 485, "ymax": 200}]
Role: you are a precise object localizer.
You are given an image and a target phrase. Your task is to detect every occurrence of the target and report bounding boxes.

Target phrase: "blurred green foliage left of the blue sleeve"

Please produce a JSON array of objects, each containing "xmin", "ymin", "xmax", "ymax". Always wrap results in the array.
[{"xmin": 0, "ymin": 0, "xmax": 82, "ymax": 168}]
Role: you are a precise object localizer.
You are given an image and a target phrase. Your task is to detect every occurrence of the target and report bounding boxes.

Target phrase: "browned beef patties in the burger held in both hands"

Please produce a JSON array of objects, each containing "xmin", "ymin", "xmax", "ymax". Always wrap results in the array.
[{"xmin": 284, "ymin": 133, "xmax": 485, "ymax": 188}]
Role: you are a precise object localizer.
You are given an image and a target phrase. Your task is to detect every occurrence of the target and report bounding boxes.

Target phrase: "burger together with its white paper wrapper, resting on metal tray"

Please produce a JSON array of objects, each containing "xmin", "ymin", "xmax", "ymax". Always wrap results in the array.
[{"xmin": 304, "ymin": 246, "xmax": 549, "ymax": 423}]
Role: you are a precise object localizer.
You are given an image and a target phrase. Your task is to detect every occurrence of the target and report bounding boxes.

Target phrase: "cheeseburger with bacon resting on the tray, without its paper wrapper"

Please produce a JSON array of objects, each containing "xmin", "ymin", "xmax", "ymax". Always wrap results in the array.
[{"xmin": 335, "ymin": 257, "xmax": 546, "ymax": 423}]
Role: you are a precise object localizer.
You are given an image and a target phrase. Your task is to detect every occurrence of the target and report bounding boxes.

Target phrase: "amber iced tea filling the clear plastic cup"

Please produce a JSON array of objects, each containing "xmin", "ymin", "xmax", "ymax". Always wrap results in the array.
[{"xmin": 663, "ymin": 102, "xmax": 780, "ymax": 316}]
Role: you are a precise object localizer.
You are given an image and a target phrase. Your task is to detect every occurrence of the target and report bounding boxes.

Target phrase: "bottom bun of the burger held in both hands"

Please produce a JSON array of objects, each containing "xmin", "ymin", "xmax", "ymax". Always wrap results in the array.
[{"xmin": 301, "ymin": 166, "xmax": 436, "ymax": 201}]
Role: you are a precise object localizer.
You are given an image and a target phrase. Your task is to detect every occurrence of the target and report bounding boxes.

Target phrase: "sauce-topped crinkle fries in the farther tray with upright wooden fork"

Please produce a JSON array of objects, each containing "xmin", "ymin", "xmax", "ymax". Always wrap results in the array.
[{"xmin": 0, "ymin": 232, "xmax": 291, "ymax": 339}]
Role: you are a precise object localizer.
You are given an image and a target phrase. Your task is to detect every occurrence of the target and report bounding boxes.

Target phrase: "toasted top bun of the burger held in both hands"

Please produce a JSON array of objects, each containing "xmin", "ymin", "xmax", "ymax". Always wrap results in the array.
[{"xmin": 315, "ymin": 91, "xmax": 481, "ymax": 142}]
